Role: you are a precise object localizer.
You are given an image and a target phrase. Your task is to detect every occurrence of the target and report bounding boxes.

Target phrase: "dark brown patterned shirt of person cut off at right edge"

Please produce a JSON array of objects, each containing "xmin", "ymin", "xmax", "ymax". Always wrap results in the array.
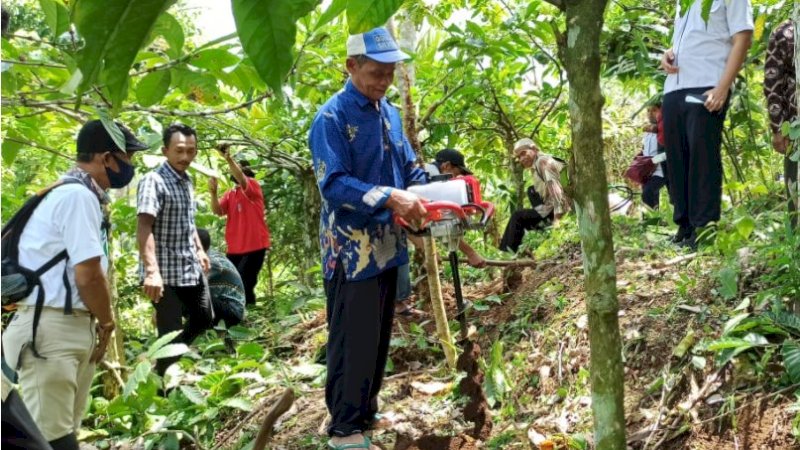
[{"xmin": 764, "ymin": 20, "xmax": 797, "ymax": 133}]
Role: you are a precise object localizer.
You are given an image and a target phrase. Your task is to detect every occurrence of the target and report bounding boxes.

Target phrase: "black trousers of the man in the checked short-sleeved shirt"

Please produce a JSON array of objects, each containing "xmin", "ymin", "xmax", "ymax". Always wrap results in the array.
[{"xmin": 154, "ymin": 280, "xmax": 214, "ymax": 375}]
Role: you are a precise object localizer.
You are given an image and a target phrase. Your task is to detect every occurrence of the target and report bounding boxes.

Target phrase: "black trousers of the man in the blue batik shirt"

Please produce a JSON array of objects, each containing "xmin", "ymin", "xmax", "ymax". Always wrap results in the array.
[{"xmin": 325, "ymin": 262, "xmax": 397, "ymax": 436}]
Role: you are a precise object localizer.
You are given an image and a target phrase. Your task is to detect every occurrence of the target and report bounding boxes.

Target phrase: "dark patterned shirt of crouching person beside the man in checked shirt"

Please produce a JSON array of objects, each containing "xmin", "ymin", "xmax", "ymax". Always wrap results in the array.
[{"xmin": 208, "ymin": 250, "xmax": 245, "ymax": 326}]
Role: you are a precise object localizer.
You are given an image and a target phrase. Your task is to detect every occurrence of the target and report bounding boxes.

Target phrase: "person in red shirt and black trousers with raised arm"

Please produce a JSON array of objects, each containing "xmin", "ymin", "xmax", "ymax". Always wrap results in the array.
[{"xmin": 208, "ymin": 144, "xmax": 270, "ymax": 305}]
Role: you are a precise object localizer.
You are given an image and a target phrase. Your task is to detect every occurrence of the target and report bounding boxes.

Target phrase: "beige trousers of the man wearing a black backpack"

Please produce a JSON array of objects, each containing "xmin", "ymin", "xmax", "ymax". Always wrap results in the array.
[{"xmin": 3, "ymin": 307, "xmax": 96, "ymax": 441}]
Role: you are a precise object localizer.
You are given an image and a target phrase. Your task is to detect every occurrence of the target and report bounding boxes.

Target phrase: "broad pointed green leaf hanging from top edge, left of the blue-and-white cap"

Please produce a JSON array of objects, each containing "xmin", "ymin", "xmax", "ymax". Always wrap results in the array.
[{"xmin": 232, "ymin": 0, "xmax": 318, "ymax": 95}]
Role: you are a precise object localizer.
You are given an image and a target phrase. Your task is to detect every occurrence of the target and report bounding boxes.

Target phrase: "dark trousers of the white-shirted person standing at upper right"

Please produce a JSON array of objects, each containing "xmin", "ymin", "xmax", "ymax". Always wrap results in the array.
[{"xmin": 662, "ymin": 88, "xmax": 728, "ymax": 228}]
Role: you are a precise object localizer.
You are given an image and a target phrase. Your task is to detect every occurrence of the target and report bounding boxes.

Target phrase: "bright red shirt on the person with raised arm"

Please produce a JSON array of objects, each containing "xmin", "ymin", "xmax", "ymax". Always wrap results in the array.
[{"xmin": 219, "ymin": 178, "xmax": 270, "ymax": 255}]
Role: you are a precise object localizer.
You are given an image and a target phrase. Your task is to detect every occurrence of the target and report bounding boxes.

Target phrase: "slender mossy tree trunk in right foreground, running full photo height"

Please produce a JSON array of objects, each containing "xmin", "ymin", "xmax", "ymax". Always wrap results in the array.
[{"xmin": 559, "ymin": 0, "xmax": 626, "ymax": 450}]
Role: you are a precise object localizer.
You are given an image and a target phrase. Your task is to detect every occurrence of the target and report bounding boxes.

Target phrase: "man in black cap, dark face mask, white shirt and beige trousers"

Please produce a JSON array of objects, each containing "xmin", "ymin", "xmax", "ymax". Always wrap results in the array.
[{"xmin": 3, "ymin": 120, "xmax": 148, "ymax": 450}]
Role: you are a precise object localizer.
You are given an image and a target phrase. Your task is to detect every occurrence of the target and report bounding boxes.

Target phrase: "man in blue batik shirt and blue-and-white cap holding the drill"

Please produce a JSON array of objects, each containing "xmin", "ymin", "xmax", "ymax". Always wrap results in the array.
[{"xmin": 309, "ymin": 28, "xmax": 426, "ymax": 449}]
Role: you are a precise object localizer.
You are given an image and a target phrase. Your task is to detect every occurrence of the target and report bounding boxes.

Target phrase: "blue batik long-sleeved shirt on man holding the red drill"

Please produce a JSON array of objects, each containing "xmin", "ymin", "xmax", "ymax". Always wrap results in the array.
[{"xmin": 309, "ymin": 81, "xmax": 425, "ymax": 281}]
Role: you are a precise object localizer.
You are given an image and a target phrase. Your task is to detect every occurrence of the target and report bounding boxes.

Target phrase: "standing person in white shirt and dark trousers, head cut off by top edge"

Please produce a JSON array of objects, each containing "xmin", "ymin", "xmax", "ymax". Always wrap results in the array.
[{"xmin": 661, "ymin": 0, "xmax": 753, "ymax": 248}]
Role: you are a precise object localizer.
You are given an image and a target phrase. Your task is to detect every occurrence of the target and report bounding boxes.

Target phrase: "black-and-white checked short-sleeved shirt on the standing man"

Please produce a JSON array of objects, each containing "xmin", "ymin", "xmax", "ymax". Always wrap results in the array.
[{"xmin": 136, "ymin": 161, "xmax": 202, "ymax": 286}]
